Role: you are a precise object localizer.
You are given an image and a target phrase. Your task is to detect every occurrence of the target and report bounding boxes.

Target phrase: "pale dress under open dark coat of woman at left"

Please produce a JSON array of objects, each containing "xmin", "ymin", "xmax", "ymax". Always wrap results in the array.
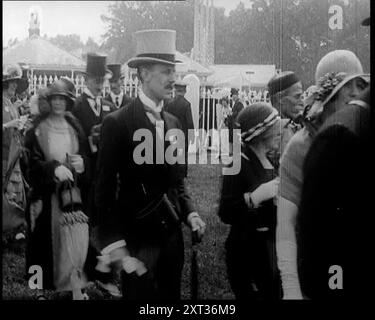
[{"xmin": 35, "ymin": 118, "xmax": 88, "ymax": 294}]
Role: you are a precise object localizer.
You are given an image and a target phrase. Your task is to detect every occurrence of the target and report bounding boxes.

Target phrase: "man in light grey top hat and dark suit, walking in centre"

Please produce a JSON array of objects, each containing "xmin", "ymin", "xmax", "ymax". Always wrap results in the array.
[{"xmin": 95, "ymin": 30, "xmax": 205, "ymax": 300}]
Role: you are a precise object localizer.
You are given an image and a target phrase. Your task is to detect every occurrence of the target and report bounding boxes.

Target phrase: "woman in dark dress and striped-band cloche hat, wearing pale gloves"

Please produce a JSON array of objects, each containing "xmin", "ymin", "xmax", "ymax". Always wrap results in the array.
[{"xmin": 219, "ymin": 103, "xmax": 281, "ymax": 301}]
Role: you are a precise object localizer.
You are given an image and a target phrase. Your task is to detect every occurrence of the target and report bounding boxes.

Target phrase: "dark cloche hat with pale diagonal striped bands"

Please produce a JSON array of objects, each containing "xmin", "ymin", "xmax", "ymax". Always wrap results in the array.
[{"xmin": 235, "ymin": 102, "xmax": 280, "ymax": 143}]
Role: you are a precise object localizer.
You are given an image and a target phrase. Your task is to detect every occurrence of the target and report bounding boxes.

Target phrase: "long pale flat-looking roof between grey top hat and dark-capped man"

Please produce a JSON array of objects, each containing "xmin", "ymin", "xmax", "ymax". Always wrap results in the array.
[{"xmin": 207, "ymin": 64, "xmax": 276, "ymax": 88}]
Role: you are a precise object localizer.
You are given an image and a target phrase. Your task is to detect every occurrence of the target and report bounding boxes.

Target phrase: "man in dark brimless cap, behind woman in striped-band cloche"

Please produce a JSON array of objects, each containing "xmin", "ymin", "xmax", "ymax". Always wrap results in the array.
[{"xmin": 268, "ymin": 71, "xmax": 303, "ymax": 156}]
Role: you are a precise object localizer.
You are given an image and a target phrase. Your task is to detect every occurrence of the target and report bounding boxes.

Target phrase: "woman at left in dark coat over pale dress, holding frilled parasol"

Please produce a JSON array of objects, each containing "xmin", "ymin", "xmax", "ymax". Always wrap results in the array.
[{"xmin": 25, "ymin": 80, "xmax": 88, "ymax": 300}]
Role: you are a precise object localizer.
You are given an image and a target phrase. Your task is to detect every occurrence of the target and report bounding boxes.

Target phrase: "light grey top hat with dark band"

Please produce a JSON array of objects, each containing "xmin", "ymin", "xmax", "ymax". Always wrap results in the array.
[{"xmin": 127, "ymin": 30, "xmax": 181, "ymax": 68}]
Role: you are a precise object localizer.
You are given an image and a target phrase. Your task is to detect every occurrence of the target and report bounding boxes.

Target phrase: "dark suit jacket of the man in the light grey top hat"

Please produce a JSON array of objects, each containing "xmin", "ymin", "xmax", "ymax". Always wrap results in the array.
[{"xmin": 95, "ymin": 98, "xmax": 195, "ymax": 247}]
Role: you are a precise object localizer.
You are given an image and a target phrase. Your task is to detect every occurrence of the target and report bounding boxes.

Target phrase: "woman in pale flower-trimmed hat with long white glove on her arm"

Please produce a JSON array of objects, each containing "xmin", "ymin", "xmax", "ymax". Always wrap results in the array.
[{"xmin": 277, "ymin": 50, "xmax": 369, "ymax": 299}]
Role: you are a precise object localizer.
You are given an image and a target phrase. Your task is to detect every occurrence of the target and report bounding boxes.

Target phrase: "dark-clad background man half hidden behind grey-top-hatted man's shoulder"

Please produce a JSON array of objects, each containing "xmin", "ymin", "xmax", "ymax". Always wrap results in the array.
[{"xmin": 165, "ymin": 81, "xmax": 194, "ymax": 177}]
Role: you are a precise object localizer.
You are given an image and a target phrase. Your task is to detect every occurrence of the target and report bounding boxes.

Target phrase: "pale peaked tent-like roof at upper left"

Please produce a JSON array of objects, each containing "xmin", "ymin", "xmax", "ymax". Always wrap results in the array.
[{"xmin": 3, "ymin": 35, "xmax": 86, "ymax": 70}]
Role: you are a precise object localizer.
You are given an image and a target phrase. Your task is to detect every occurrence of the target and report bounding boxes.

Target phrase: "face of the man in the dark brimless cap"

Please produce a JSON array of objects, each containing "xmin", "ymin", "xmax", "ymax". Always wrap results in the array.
[{"xmin": 280, "ymin": 82, "xmax": 303, "ymax": 119}]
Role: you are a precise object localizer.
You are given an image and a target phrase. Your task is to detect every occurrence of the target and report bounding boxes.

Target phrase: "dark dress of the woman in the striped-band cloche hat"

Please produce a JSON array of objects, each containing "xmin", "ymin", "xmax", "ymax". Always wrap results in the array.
[{"xmin": 219, "ymin": 148, "xmax": 280, "ymax": 301}]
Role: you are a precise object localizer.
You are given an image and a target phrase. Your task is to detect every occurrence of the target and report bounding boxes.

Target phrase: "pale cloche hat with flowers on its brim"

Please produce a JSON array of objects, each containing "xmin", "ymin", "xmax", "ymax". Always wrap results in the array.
[{"xmin": 308, "ymin": 50, "xmax": 370, "ymax": 117}]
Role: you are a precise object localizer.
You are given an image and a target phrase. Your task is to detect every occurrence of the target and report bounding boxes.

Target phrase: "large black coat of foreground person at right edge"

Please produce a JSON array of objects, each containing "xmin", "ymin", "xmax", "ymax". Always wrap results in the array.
[{"xmin": 297, "ymin": 91, "xmax": 374, "ymax": 299}]
